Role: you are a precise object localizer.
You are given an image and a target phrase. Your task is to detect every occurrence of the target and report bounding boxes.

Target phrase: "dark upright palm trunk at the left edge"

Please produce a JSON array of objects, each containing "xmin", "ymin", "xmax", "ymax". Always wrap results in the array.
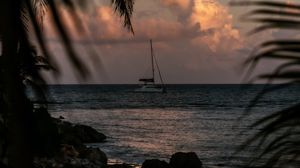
[{"xmin": 0, "ymin": 0, "xmax": 33, "ymax": 168}]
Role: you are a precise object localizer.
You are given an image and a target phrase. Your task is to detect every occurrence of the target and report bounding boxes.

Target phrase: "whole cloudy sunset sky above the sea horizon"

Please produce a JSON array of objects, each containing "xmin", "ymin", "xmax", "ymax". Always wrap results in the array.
[{"xmin": 44, "ymin": 0, "xmax": 292, "ymax": 84}]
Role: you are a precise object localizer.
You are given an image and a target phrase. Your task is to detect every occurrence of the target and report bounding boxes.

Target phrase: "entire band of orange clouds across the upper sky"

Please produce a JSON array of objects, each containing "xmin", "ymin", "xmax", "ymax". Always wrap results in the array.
[{"xmin": 46, "ymin": 0, "xmax": 242, "ymax": 52}]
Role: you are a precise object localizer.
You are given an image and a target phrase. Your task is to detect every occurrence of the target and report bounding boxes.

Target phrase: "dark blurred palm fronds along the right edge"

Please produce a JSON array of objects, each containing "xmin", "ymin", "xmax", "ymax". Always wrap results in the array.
[{"xmin": 231, "ymin": 0, "xmax": 300, "ymax": 167}]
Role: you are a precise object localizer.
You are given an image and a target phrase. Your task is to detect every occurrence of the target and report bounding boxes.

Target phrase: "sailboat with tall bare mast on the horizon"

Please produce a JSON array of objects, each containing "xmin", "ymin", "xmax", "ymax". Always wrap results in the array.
[{"xmin": 135, "ymin": 40, "xmax": 166, "ymax": 93}]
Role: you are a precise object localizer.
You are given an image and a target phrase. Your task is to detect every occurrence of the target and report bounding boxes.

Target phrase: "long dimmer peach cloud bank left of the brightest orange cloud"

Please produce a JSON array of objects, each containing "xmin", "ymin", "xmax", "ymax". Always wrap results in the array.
[{"xmin": 46, "ymin": 6, "xmax": 210, "ymax": 44}]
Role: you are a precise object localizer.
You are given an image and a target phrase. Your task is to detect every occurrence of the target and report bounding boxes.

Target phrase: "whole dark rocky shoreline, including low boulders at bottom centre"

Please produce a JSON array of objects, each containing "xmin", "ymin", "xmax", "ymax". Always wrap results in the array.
[{"xmin": 34, "ymin": 111, "xmax": 203, "ymax": 168}]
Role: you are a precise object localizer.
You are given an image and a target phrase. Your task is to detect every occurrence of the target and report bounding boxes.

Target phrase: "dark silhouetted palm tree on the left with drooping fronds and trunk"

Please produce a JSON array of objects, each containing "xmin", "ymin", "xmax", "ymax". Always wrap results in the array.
[{"xmin": 0, "ymin": 0, "xmax": 133, "ymax": 168}]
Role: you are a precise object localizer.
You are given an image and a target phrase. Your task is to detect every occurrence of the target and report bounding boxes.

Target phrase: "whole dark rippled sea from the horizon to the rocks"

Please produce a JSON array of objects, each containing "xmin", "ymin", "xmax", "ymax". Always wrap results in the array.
[{"xmin": 39, "ymin": 85, "xmax": 300, "ymax": 168}]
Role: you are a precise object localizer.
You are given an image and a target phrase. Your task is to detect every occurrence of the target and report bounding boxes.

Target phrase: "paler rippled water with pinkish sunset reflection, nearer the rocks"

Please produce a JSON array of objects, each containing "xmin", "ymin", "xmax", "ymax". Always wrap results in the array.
[{"xmin": 52, "ymin": 109, "xmax": 262, "ymax": 166}]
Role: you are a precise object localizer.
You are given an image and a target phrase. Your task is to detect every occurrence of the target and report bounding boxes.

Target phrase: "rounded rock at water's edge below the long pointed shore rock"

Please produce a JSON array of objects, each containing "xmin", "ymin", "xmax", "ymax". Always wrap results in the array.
[{"xmin": 79, "ymin": 148, "xmax": 107, "ymax": 165}]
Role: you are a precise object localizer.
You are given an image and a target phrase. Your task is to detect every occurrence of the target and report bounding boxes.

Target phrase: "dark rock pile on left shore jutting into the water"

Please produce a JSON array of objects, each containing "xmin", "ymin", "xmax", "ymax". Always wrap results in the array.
[{"xmin": 29, "ymin": 108, "xmax": 107, "ymax": 168}]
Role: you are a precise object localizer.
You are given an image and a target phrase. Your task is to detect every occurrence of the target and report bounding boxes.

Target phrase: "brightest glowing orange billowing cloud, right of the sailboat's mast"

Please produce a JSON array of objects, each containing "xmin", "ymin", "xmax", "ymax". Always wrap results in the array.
[{"xmin": 190, "ymin": 0, "xmax": 243, "ymax": 53}]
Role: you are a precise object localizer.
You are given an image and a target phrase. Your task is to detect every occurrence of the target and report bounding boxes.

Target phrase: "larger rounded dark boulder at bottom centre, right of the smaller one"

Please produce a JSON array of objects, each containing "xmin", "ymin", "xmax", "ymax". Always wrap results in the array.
[{"xmin": 170, "ymin": 152, "xmax": 203, "ymax": 168}]
